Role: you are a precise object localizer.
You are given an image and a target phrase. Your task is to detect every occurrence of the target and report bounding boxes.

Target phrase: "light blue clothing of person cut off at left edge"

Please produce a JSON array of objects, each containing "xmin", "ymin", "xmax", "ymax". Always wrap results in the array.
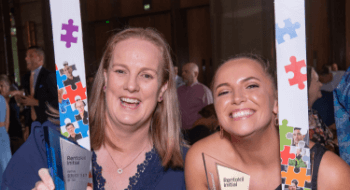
[{"xmin": 0, "ymin": 95, "xmax": 12, "ymax": 190}]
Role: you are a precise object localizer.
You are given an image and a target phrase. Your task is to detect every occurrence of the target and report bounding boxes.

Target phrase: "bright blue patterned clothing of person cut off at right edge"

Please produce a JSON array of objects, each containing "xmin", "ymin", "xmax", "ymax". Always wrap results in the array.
[{"xmin": 333, "ymin": 67, "xmax": 350, "ymax": 165}]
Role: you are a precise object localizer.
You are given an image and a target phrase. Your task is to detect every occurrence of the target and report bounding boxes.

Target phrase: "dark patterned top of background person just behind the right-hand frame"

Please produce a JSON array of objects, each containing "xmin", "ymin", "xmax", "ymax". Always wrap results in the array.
[{"xmin": 309, "ymin": 109, "xmax": 338, "ymax": 152}]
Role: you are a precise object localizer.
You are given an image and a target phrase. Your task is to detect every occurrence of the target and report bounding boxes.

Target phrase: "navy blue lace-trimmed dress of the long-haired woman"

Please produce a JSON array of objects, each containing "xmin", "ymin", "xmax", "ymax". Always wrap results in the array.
[{"xmin": 1, "ymin": 122, "xmax": 187, "ymax": 190}]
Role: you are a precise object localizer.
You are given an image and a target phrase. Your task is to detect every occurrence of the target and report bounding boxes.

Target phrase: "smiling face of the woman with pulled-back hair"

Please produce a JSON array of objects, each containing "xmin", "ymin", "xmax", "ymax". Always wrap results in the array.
[{"xmin": 213, "ymin": 58, "xmax": 278, "ymax": 137}]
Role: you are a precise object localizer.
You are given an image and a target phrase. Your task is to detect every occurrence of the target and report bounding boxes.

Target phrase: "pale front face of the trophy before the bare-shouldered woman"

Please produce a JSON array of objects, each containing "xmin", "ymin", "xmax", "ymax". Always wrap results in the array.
[{"xmin": 216, "ymin": 164, "xmax": 250, "ymax": 190}]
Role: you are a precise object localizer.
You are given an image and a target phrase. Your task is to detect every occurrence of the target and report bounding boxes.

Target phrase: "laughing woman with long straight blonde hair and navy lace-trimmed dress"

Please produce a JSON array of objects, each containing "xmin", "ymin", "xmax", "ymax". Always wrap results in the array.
[{"xmin": 3, "ymin": 28, "xmax": 187, "ymax": 189}]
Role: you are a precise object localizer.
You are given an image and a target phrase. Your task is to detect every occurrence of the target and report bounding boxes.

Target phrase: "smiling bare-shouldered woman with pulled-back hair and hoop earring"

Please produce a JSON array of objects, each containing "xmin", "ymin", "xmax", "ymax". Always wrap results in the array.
[{"xmin": 185, "ymin": 54, "xmax": 350, "ymax": 190}]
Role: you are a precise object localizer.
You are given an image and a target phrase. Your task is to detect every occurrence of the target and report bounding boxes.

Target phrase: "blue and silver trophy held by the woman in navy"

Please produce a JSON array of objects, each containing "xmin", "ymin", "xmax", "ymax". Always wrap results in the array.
[{"xmin": 44, "ymin": 127, "xmax": 92, "ymax": 190}]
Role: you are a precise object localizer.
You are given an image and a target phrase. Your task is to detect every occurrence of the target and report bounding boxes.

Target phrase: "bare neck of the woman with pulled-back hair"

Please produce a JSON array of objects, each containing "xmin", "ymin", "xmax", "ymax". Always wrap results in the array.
[{"xmin": 231, "ymin": 124, "xmax": 280, "ymax": 166}]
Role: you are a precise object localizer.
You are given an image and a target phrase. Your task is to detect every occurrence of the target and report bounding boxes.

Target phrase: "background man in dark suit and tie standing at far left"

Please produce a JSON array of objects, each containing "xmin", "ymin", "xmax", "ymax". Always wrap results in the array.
[{"xmin": 11, "ymin": 46, "xmax": 58, "ymax": 140}]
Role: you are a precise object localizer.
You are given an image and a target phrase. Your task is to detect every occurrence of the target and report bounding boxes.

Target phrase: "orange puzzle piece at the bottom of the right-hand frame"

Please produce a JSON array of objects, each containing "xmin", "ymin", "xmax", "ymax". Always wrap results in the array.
[{"xmin": 281, "ymin": 166, "xmax": 311, "ymax": 187}]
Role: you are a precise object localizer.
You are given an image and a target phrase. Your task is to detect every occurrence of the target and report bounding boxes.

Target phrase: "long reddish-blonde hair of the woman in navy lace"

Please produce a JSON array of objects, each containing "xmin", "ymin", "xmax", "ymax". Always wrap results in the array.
[{"xmin": 89, "ymin": 28, "xmax": 184, "ymax": 168}]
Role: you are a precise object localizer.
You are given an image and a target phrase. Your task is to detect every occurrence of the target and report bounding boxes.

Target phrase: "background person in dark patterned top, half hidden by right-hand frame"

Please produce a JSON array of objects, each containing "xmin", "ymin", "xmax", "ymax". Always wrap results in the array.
[{"xmin": 307, "ymin": 66, "xmax": 339, "ymax": 155}]
